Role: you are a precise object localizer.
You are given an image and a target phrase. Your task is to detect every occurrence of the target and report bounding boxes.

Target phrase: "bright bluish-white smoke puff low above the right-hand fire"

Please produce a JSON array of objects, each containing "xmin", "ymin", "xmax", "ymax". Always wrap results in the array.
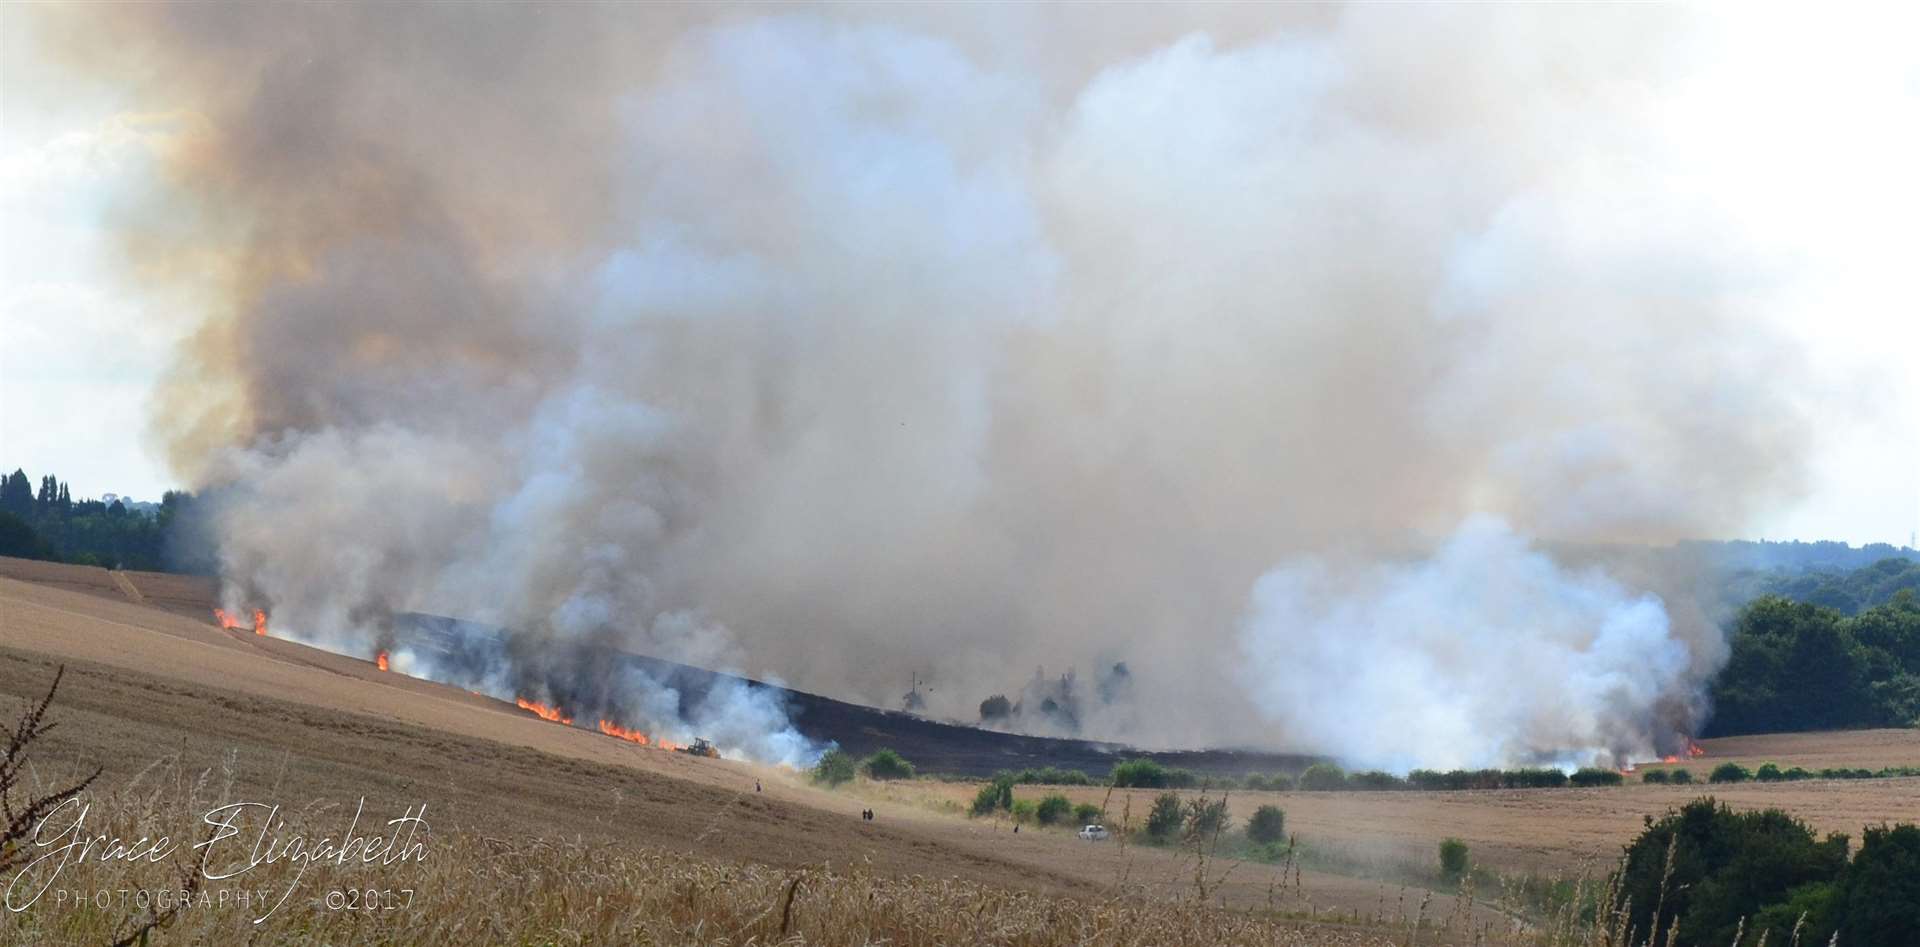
[{"xmin": 1238, "ymin": 517, "xmax": 1701, "ymax": 772}]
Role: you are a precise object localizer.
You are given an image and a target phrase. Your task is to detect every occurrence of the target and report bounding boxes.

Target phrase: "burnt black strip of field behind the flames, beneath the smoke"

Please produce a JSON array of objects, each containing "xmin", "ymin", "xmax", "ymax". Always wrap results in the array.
[{"xmin": 392, "ymin": 615, "xmax": 1319, "ymax": 780}]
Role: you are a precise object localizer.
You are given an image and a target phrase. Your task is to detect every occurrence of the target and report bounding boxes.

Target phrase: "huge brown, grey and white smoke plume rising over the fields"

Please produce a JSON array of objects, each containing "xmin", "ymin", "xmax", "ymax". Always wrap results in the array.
[{"xmin": 46, "ymin": 4, "xmax": 1809, "ymax": 766}]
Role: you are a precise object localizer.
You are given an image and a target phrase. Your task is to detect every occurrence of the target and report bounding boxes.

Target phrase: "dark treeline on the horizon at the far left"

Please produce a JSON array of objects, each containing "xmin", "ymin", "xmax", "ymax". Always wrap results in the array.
[{"xmin": 0, "ymin": 469, "xmax": 213, "ymax": 574}]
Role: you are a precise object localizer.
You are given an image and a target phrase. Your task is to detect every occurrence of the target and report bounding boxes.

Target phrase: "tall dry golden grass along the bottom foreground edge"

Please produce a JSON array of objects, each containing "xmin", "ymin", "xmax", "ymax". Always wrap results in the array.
[{"xmin": 0, "ymin": 761, "xmax": 1482, "ymax": 947}]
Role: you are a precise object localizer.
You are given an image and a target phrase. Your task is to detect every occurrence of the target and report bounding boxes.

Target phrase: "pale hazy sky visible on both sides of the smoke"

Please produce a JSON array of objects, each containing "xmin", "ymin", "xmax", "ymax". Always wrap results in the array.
[{"xmin": 0, "ymin": 6, "xmax": 1920, "ymax": 544}]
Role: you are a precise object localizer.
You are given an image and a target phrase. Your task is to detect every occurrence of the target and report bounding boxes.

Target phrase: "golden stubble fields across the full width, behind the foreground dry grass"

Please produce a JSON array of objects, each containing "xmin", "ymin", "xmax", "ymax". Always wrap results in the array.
[{"xmin": 0, "ymin": 559, "xmax": 1920, "ymax": 943}]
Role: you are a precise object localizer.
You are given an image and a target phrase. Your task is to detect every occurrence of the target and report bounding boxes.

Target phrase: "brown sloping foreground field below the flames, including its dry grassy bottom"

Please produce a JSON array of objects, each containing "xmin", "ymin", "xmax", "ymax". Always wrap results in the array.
[{"xmin": 0, "ymin": 563, "xmax": 1507, "ymax": 943}]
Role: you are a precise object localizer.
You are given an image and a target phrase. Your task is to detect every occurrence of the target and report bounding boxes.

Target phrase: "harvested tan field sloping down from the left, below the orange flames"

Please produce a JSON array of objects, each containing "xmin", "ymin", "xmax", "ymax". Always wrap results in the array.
[{"xmin": 0, "ymin": 567, "xmax": 1507, "ymax": 943}]
